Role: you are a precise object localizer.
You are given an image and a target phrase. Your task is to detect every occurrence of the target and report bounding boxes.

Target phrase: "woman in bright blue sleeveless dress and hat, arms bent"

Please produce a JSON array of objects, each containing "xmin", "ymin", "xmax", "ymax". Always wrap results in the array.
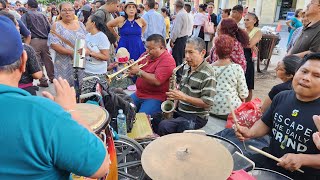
[{"xmin": 107, "ymin": 1, "xmax": 147, "ymax": 60}]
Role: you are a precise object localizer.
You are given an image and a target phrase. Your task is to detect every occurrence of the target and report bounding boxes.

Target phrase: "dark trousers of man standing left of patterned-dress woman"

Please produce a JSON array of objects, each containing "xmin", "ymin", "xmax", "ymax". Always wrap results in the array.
[{"xmin": 30, "ymin": 38, "xmax": 54, "ymax": 82}]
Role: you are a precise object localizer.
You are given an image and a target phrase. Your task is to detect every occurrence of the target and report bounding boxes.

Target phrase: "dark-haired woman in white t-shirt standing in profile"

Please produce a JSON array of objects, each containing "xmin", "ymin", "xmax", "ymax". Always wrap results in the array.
[{"xmin": 82, "ymin": 15, "xmax": 110, "ymax": 93}]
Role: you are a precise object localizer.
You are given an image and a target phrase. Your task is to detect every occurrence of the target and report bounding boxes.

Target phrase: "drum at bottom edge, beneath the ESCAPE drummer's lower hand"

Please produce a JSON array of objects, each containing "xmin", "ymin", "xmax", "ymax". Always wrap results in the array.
[{"xmin": 248, "ymin": 168, "xmax": 293, "ymax": 180}]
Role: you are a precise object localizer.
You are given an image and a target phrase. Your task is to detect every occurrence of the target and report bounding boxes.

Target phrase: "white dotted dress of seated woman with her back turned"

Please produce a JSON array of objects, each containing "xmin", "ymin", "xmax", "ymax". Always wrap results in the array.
[{"xmin": 210, "ymin": 64, "xmax": 249, "ymax": 115}]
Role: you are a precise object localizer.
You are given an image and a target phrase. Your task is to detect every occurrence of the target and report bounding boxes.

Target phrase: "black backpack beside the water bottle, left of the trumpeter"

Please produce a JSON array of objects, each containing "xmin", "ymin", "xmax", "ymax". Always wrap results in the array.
[{"xmin": 102, "ymin": 88, "xmax": 136, "ymax": 132}]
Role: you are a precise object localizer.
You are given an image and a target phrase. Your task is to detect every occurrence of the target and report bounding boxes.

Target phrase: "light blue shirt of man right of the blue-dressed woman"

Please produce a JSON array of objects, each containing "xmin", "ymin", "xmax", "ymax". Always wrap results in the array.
[{"xmin": 142, "ymin": 9, "xmax": 166, "ymax": 41}]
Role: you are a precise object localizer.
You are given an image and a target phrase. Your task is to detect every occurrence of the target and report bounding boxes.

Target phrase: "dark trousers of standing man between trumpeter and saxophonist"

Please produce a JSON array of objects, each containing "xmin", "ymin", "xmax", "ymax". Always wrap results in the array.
[{"xmin": 172, "ymin": 36, "xmax": 188, "ymax": 82}]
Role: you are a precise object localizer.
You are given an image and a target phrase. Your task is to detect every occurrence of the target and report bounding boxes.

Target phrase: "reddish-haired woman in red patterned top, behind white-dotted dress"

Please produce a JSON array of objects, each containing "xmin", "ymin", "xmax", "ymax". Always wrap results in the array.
[{"xmin": 206, "ymin": 18, "xmax": 249, "ymax": 71}]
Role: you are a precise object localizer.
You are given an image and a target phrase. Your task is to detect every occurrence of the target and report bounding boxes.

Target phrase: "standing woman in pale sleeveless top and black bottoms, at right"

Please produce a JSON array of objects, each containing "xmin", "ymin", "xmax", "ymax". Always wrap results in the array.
[{"xmin": 244, "ymin": 13, "xmax": 262, "ymax": 101}]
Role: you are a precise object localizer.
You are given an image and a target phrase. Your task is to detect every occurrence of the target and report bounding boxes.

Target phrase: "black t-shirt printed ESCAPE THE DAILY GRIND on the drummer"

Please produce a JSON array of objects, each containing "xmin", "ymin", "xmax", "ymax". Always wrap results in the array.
[{"xmin": 261, "ymin": 90, "xmax": 320, "ymax": 176}]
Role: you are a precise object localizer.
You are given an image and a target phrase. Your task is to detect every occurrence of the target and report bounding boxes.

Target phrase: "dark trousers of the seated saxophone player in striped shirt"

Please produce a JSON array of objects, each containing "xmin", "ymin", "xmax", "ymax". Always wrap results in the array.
[{"xmin": 158, "ymin": 111, "xmax": 208, "ymax": 136}]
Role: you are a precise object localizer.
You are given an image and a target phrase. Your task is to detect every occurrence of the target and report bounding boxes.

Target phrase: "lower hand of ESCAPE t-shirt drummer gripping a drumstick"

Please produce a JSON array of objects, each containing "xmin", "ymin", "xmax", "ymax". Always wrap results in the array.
[{"xmin": 277, "ymin": 153, "xmax": 303, "ymax": 172}]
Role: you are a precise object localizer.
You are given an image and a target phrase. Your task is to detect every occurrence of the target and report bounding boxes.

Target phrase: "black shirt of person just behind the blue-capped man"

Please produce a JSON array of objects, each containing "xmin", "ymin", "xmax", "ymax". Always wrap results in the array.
[{"xmin": 19, "ymin": 44, "xmax": 41, "ymax": 84}]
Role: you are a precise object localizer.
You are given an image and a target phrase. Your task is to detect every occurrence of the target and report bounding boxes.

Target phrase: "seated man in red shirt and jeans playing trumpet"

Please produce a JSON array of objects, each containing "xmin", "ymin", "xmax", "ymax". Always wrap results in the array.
[{"xmin": 129, "ymin": 34, "xmax": 176, "ymax": 115}]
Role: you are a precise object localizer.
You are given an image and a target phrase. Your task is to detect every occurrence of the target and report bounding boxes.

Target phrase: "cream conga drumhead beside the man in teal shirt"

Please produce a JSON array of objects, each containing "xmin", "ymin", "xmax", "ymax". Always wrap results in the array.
[{"xmin": 76, "ymin": 103, "xmax": 109, "ymax": 132}]
